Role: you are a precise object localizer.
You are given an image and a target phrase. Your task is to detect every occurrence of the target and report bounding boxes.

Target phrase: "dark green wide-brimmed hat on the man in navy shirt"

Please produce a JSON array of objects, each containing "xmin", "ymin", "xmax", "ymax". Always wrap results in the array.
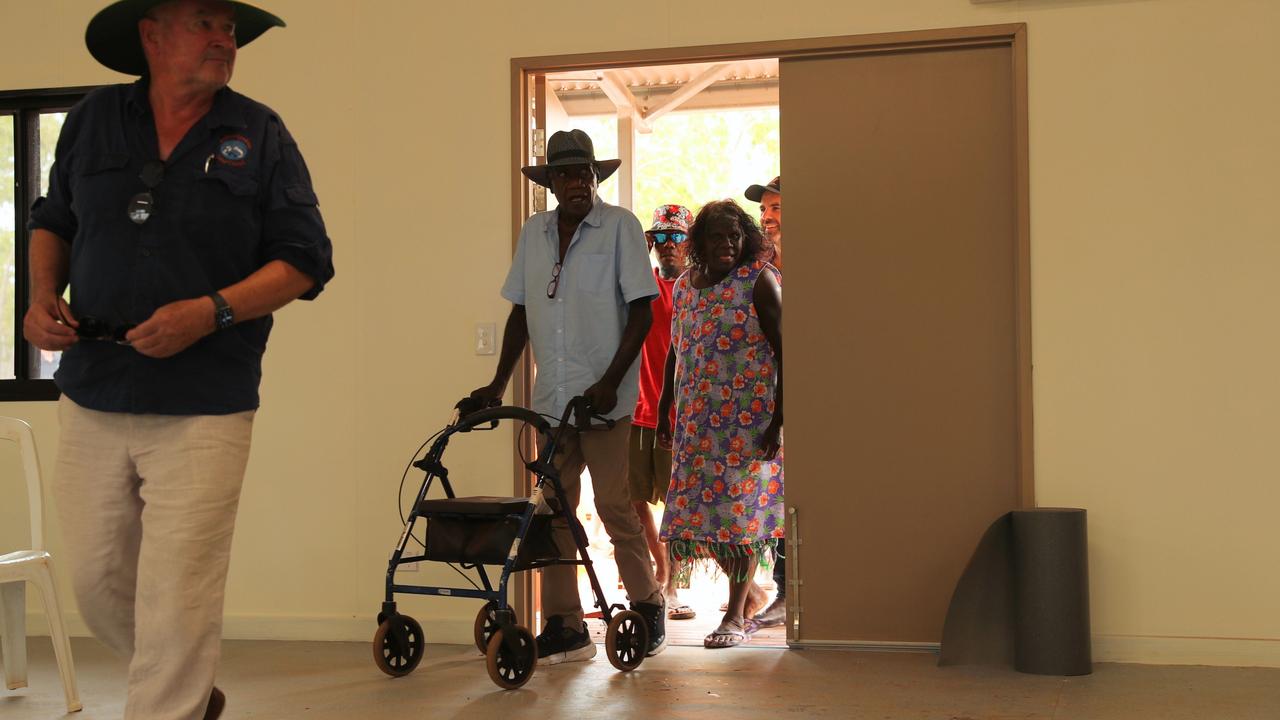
[{"xmin": 84, "ymin": 0, "xmax": 284, "ymax": 76}]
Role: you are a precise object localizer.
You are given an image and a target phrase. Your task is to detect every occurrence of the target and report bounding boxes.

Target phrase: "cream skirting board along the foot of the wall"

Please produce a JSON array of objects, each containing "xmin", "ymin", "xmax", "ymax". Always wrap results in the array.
[{"xmin": 27, "ymin": 612, "xmax": 1280, "ymax": 667}]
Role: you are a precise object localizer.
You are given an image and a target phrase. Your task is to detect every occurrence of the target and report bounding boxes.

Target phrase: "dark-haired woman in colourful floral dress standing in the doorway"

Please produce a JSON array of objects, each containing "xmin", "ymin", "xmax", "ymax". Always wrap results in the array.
[{"xmin": 657, "ymin": 200, "xmax": 785, "ymax": 648}]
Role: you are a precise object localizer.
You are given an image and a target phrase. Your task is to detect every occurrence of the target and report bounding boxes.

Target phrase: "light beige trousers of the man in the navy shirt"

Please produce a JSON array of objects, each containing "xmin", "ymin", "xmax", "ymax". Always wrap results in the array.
[{"xmin": 54, "ymin": 396, "xmax": 253, "ymax": 720}]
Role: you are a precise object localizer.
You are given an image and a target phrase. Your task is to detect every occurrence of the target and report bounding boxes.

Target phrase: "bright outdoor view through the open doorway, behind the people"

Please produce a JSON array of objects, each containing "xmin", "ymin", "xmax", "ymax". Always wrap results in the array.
[{"xmin": 534, "ymin": 59, "xmax": 786, "ymax": 647}]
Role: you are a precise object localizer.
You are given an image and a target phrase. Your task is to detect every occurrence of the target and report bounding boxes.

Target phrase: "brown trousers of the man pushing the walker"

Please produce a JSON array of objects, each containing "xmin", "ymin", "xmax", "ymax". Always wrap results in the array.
[{"xmin": 541, "ymin": 418, "xmax": 662, "ymax": 628}]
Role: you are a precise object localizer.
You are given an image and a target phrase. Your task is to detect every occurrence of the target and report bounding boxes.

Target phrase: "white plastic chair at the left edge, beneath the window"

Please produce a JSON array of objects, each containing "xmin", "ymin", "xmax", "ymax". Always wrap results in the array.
[{"xmin": 0, "ymin": 416, "xmax": 83, "ymax": 712}]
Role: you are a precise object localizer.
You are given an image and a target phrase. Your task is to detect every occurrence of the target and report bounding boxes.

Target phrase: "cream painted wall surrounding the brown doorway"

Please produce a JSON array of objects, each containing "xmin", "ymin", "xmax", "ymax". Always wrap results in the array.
[{"xmin": 0, "ymin": 0, "xmax": 1280, "ymax": 665}]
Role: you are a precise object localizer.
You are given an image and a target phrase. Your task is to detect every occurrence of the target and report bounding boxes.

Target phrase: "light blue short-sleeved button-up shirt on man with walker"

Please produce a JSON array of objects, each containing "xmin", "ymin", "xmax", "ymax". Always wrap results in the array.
[{"xmin": 502, "ymin": 197, "xmax": 658, "ymax": 419}]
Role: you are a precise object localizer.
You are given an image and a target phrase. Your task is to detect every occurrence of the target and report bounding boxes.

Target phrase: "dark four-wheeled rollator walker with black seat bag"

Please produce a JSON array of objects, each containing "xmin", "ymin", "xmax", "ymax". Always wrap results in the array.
[{"xmin": 374, "ymin": 397, "xmax": 649, "ymax": 689}]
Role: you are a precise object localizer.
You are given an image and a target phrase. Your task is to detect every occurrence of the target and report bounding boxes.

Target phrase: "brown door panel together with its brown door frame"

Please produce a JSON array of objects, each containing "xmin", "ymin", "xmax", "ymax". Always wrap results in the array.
[{"xmin": 511, "ymin": 24, "xmax": 1034, "ymax": 651}]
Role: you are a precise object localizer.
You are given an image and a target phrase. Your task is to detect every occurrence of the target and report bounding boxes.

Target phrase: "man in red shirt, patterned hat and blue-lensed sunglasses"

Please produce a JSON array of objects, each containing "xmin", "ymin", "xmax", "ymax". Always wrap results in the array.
[{"xmin": 627, "ymin": 205, "xmax": 694, "ymax": 620}]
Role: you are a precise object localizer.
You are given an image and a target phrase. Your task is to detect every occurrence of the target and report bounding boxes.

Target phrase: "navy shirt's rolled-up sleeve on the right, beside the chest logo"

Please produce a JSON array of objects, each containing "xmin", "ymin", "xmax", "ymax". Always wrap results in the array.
[{"xmin": 259, "ymin": 118, "xmax": 334, "ymax": 300}]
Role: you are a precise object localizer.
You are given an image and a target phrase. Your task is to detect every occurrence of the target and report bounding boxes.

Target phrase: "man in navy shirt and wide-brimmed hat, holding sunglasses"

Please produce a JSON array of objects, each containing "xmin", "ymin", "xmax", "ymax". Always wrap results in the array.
[{"xmin": 23, "ymin": 0, "xmax": 333, "ymax": 720}]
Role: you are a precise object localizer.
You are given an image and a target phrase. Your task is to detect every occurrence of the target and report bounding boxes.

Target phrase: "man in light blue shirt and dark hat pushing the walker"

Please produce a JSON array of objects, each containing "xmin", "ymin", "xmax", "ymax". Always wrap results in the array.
[{"xmin": 471, "ymin": 129, "xmax": 667, "ymax": 665}]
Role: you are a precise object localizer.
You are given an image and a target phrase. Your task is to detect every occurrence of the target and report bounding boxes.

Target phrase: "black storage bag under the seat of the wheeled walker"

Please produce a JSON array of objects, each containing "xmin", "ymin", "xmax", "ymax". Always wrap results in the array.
[{"xmin": 417, "ymin": 496, "xmax": 559, "ymax": 569}]
